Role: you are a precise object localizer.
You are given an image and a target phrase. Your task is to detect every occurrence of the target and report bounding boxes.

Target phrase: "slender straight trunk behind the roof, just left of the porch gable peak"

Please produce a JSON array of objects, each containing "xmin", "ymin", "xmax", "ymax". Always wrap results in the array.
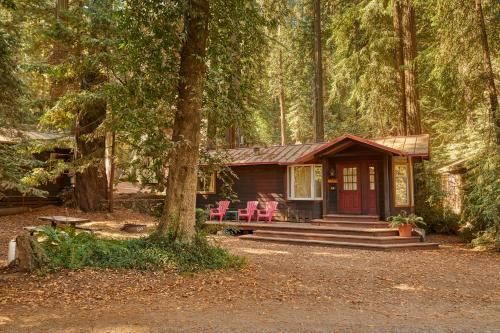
[{"xmin": 313, "ymin": 0, "xmax": 325, "ymax": 142}]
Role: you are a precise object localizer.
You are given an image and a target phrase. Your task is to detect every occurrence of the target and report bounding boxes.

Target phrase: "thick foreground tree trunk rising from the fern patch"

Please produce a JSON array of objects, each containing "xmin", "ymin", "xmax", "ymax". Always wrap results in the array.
[{"xmin": 158, "ymin": 0, "xmax": 209, "ymax": 240}]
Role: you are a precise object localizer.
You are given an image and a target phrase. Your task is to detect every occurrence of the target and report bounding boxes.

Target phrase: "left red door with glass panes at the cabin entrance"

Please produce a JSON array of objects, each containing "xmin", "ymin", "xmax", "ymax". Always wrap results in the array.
[{"xmin": 338, "ymin": 164, "xmax": 361, "ymax": 214}]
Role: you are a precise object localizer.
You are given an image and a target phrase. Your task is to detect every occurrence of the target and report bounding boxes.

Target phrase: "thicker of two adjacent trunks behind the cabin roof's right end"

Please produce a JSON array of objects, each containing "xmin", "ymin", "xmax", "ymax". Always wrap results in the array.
[{"xmin": 402, "ymin": 0, "xmax": 422, "ymax": 134}]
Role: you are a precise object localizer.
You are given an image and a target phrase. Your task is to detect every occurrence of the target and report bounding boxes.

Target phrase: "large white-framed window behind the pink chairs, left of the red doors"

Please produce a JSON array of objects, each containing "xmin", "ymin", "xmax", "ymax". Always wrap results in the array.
[{"xmin": 288, "ymin": 164, "xmax": 323, "ymax": 200}]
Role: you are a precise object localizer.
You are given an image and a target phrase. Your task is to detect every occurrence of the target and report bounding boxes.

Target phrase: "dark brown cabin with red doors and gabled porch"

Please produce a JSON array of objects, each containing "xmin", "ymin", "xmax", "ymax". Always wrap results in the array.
[{"xmin": 197, "ymin": 134, "xmax": 429, "ymax": 222}]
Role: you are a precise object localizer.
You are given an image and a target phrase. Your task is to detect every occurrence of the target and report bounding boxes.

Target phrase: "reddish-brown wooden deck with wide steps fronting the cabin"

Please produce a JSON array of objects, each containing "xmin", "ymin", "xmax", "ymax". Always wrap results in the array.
[{"xmin": 206, "ymin": 221, "xmax": 438, "ymax": 250}]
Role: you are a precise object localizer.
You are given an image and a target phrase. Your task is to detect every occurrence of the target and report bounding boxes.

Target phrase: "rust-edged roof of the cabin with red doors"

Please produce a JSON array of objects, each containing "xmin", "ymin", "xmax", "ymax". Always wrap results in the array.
[{"xmin": 217, "ymin": 134, "xmax": 429, "ymax": 166}]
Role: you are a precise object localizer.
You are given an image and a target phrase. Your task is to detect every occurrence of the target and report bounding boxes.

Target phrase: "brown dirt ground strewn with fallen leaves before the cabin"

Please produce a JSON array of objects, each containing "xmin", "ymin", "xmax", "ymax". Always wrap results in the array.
[{"xmin": 0, "ymin": 208, "xmax": 500, "ymax": 332}]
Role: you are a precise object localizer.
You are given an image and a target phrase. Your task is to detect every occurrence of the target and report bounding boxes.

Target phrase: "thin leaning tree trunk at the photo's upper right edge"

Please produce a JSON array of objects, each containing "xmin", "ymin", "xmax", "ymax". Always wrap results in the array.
[{"xmin": 476, "ymin": 0, "xmax": 500, "ymax": 145}]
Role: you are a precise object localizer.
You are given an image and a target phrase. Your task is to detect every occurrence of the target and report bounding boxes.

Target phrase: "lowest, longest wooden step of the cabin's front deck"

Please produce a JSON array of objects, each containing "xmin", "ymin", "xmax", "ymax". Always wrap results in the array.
[{"xmin": 240, "ymin": 235, "xmax": 439, "ymax": 250}]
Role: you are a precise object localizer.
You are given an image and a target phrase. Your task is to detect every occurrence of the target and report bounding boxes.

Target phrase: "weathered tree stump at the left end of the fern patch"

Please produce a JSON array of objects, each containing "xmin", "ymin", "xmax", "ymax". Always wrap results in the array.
[{"xmin": 12, "ymin": 234, "xmax": 48, "ymax": 272}]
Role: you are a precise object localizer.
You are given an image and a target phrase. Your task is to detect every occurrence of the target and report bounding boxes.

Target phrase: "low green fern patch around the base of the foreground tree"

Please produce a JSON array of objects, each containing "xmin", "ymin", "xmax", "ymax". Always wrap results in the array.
[{"xmin": 41, "ymin": 227, "xmax": 244, "ymax": 272}]
